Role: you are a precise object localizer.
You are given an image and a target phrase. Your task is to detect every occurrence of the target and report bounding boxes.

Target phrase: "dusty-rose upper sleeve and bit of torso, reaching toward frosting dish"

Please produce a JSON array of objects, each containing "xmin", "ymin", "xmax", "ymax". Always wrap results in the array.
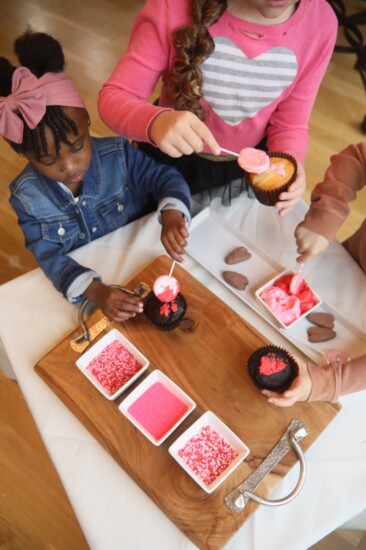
[{"xmin": 301, "ymin": 143, "xmax": 366, "ymax": 273}]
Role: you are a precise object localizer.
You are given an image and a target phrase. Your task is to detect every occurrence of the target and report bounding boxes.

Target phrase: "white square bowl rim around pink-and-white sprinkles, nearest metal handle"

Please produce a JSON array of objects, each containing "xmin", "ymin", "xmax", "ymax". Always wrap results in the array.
[{"xmin": 169, "ymin": 411, "xmax": 249, "ymax": 493}]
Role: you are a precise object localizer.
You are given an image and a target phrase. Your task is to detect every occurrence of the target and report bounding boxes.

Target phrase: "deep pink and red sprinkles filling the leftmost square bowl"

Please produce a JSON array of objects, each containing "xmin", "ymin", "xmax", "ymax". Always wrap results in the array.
[{"xmin": 86, "ymin": 340, "xmax": 142, "ymax": 395}]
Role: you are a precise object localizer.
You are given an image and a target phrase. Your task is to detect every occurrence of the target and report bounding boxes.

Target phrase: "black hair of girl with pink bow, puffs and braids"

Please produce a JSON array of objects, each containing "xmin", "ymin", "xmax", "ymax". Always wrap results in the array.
[{"xmin": 0, "ymin": 29, "xmax": 78, "ymax": 158}]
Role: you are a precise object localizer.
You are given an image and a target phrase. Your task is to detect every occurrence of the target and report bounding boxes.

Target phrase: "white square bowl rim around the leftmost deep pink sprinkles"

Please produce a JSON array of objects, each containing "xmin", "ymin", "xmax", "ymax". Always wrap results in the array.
[{"xmin": 76, "ymin": 329, "xmax": 149, "ymax": 401}]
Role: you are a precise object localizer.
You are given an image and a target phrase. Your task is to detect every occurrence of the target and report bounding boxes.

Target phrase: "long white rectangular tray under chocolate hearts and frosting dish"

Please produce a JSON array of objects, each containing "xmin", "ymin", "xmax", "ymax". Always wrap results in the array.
[{"xmin": 187, "ymin": 208, "xmax": 366, "ymax": 362}]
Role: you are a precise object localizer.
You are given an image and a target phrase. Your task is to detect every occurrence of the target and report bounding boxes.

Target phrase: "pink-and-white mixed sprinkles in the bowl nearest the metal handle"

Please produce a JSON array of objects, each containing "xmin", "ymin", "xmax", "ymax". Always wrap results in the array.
[{"xmin": 178, "ymin": 426, "xmax": 239, "ymax": 485}]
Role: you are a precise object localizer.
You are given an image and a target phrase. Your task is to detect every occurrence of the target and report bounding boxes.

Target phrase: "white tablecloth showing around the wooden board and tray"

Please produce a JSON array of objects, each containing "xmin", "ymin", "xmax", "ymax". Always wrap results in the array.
[{"xmin": 0, "ymin": 197, "xmax": 366, "ymax": 550}]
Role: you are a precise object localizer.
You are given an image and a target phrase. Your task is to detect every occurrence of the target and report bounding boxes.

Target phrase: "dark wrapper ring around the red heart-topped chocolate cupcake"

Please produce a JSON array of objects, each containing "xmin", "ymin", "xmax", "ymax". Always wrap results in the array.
[{"xmin": 247, "ymin": 346, "xmax": 299, "ymax": 393}]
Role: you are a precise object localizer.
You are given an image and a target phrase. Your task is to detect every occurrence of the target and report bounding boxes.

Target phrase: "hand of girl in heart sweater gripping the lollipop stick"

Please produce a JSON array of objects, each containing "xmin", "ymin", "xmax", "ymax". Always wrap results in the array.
[{"xmin": 149, "ymin": 111, "xmax": 221, "ymax": 158}]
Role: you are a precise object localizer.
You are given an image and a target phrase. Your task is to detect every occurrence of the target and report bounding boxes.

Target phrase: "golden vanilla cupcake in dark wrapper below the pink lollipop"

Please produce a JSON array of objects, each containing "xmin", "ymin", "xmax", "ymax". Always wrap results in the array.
[{"xmin": 247, "ymin": 152, "xmax": 297, "ymax": 206}]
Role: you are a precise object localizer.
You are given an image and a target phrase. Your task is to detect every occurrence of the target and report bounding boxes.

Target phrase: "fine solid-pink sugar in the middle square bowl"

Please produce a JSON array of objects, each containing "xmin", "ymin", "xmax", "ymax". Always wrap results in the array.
[{"xmin": 128, "ymin": 382, "xmax": 188, "ymax": 440}]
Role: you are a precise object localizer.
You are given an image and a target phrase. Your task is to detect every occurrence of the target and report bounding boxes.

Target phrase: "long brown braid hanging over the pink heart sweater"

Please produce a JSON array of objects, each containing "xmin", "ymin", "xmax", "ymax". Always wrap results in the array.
[{"xmin": 168, "ymin": 0, "xmax": 227, "ymax": 120}]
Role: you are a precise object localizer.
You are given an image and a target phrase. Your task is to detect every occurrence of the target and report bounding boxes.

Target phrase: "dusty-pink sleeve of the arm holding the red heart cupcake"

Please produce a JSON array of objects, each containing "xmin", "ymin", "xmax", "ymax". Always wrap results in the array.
[{"xmin": 308, "ymin": 354, "xmax": 366, "ymax": 403}]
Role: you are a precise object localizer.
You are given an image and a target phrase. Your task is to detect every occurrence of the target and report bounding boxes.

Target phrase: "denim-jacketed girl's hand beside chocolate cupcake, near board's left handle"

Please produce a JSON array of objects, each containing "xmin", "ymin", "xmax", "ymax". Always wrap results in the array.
[{"xmin": 84, "ymin": 279, "xmax": 143, "ymax": 323}]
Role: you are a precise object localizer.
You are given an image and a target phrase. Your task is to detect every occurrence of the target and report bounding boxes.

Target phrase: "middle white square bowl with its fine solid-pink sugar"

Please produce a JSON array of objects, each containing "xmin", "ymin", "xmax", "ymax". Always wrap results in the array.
[{"xmin": 118, "ymin": 369, "xmax": 196, "ymax": 445}]
